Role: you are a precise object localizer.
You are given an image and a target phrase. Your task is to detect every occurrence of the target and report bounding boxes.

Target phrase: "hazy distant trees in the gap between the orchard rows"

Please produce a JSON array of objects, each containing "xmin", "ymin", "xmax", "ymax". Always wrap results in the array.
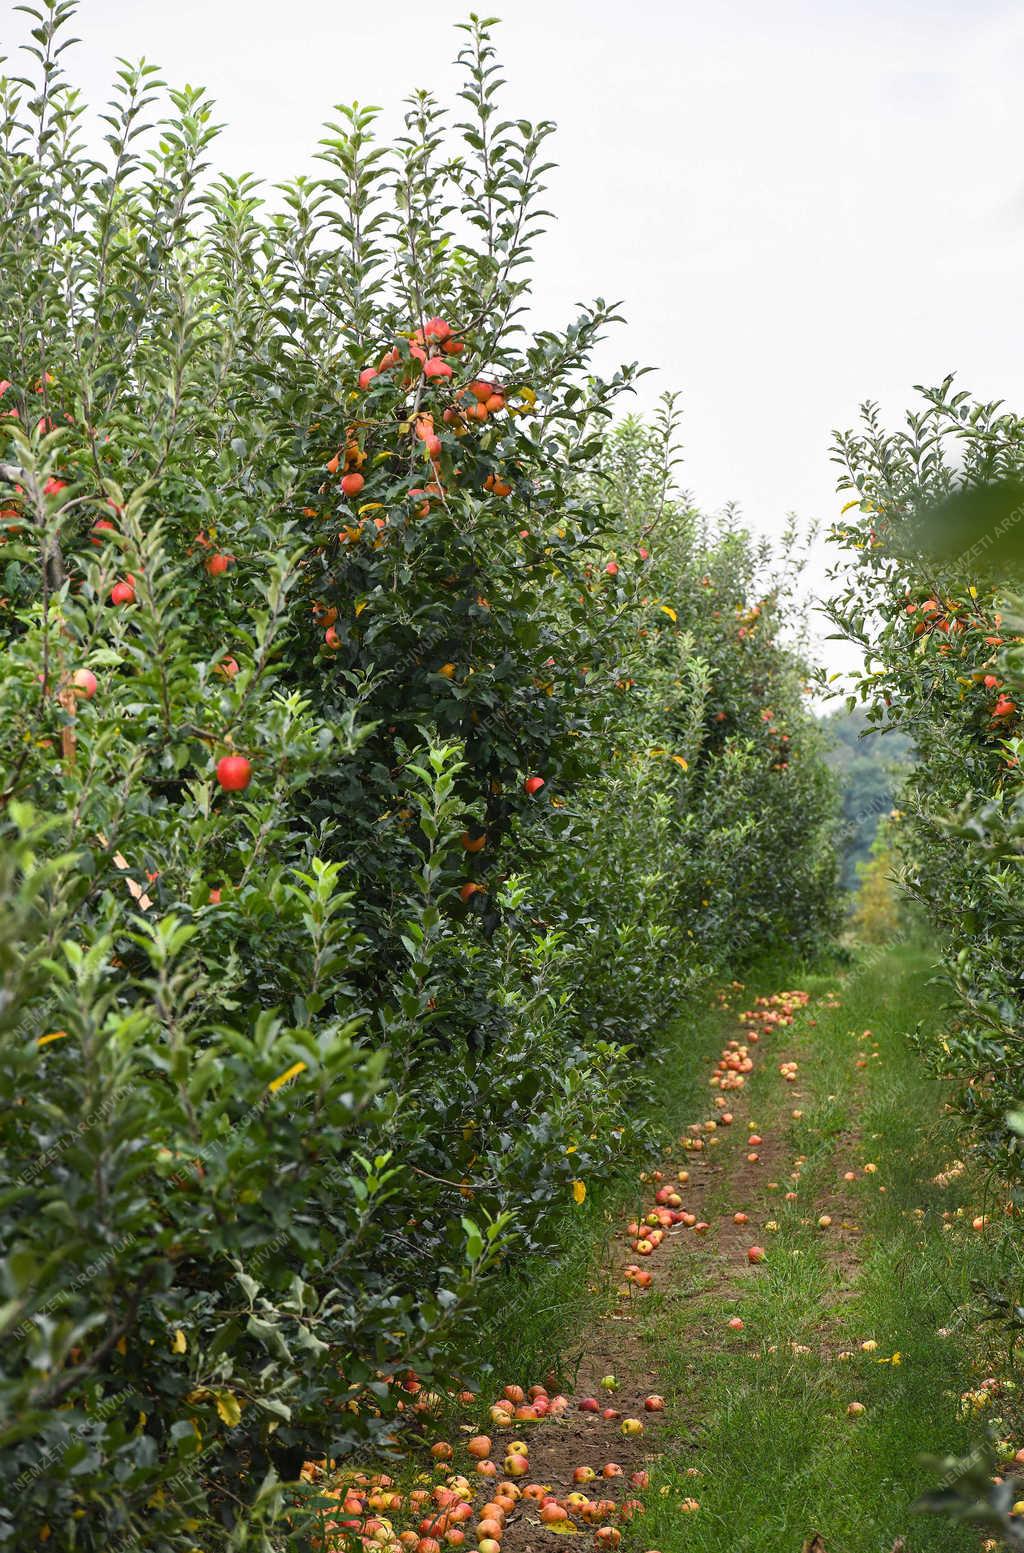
[{"xmin": 822, "ymin": 707, "xmax": 914, "ymax": 890}]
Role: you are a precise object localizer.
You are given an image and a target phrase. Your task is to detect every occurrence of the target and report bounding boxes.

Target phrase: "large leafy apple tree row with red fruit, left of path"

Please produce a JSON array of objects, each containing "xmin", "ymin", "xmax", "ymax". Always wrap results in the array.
[{"xmin": 0, "ymin": 0, "xmax": 834, "ymax": 1550}]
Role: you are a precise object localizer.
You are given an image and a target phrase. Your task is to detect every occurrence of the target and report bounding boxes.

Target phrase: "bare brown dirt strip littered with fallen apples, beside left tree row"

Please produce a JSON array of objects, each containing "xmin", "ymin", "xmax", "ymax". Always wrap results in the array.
[{"xmin": 486, "ymin": 992, "xmax": 832, "ymax": 1553}]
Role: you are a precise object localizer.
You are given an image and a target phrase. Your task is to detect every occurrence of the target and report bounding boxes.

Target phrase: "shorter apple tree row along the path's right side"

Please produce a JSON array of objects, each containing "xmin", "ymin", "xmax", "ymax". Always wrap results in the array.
[{"xmin": 833, "ymin": 379, "xmax": 1024, "ymax": 1174}]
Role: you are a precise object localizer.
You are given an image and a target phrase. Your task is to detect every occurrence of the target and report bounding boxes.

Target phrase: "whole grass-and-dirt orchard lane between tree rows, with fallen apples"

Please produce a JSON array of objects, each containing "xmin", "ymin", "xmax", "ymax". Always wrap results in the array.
[{"xmin": 320, "ymin": 950, "xmax": 1006, "ymax": 1553}]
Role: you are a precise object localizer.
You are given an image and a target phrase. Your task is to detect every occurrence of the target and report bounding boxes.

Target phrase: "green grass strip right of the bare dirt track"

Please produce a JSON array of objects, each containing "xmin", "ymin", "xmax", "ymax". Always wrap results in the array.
[{"xmin": 629, "ymin": 949, "xmax": 1019, "ymax": 1553}]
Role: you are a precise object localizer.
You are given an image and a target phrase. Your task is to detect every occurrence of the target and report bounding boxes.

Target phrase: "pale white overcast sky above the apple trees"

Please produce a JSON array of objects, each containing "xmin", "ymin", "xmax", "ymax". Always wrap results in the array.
[{"xmin": 13, "ymin": 0, "xmax": 1024, "ymax": 674}]
